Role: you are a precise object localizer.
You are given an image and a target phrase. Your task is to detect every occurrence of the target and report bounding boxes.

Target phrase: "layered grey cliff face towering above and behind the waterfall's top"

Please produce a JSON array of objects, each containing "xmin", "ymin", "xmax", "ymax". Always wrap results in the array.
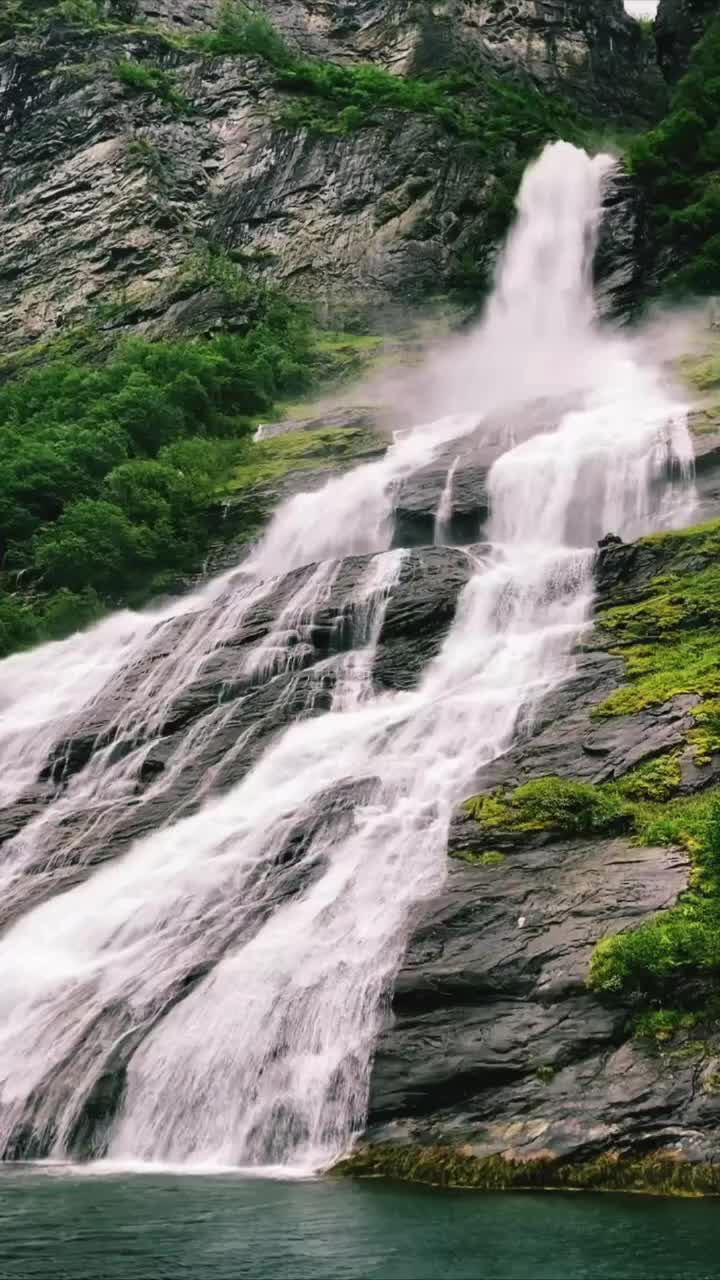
[{"xmin": 0, "ymin": 0, "xmax": 655, "ymax": 351}]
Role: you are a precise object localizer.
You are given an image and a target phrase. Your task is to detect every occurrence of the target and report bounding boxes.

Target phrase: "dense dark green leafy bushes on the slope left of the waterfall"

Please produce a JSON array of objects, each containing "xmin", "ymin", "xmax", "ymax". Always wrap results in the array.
[{"xmin": 0, "ymin": 291, "xmax": 310, "ymax": 653}]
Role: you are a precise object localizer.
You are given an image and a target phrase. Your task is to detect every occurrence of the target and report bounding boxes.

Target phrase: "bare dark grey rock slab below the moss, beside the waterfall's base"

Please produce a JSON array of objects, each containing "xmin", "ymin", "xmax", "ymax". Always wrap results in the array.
[{"xmin": 369, "ymin": 840, "xmax": 707, "ymax": 1160}]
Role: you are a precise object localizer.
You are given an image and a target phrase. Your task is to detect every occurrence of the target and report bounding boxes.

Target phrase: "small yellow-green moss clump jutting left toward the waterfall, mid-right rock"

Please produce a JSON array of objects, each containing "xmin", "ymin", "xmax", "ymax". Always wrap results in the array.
[{"xmin": 464, "ymin": 777, "xmax": 628, "ymax": 836}]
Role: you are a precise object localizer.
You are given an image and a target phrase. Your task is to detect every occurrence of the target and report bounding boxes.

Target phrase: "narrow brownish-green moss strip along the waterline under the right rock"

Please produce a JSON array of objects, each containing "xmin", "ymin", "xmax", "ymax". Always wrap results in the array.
[{"xmin": 333, "ymin": 1143, "xmax": 720, "ymax": 1196}]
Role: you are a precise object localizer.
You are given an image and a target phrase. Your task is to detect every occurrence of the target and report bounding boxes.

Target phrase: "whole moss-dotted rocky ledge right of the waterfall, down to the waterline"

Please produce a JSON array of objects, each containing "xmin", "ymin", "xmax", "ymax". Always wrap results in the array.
[{"xmin": 340, "ymin": 525, "xmax": 720, "ymax": 1192}]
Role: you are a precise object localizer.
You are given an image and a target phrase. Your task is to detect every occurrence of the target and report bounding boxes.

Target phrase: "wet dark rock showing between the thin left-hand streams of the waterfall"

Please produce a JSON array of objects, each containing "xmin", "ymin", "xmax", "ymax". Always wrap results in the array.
[{"xmin": 0, "ymin": 547, "xmax": 473, "ymax": 923}]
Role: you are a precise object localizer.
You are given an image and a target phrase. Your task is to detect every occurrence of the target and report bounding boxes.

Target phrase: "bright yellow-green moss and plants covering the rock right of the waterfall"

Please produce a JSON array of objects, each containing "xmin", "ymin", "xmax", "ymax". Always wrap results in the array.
[{"xmin": 465, "ymin": 509, "xmax": 720, "ymax": 1004}]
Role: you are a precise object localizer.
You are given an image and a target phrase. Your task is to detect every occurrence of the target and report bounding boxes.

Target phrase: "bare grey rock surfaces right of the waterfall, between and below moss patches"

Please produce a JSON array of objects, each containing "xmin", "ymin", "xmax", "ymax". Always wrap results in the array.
[{"xmin": 360, "ymin": 541, "xmax": 720, "ymax": 1167}]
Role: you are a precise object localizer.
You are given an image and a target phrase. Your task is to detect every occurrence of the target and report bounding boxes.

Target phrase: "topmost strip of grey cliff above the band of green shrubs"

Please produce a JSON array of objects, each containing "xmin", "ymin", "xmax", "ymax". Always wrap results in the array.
[{"xmin": 117, "ymin": 0, "xmax": 659, "ymax": 116}]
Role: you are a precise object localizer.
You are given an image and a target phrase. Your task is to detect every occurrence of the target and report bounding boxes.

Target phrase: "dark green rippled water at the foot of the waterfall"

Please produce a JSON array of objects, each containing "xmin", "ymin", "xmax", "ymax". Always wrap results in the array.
[{"xmin": 0, "ymin": 1171, "xmax": 720, "ymax": 1280}]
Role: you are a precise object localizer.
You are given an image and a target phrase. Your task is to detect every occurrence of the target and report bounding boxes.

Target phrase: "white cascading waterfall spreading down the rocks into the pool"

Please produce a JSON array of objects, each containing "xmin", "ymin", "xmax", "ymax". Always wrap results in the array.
[{"xmin": 0, "ymin": 143, "xmax": 692, "ymax": 1170}]
